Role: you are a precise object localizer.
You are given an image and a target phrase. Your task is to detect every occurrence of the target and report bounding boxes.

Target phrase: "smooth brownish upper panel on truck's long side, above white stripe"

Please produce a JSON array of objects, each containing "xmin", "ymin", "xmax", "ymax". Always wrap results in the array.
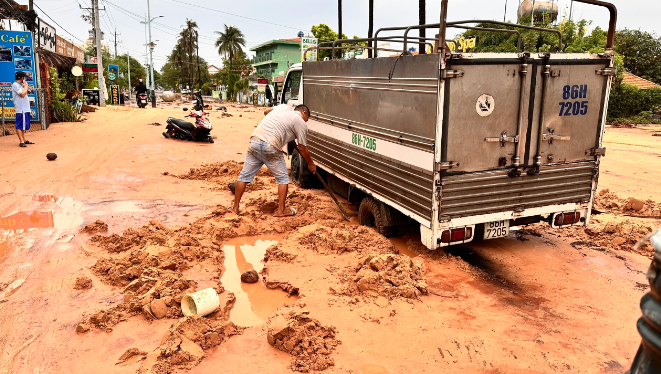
[{"xmin": 303, "ymin": 54, "xmax": 440, "ymax": 150}]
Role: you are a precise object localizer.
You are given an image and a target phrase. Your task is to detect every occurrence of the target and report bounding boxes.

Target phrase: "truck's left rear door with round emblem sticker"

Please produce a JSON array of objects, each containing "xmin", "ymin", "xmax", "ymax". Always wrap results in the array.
[{"xmin": 442, "ymin": 59, "xmax": 529, "ymax": 172}]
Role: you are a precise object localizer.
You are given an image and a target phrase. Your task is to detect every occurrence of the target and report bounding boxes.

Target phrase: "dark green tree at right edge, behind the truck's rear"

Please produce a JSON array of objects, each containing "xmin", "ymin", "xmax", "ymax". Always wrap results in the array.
[{"xmin": 615, "ymin": 29, "xmax": 661, "ymax": 84}]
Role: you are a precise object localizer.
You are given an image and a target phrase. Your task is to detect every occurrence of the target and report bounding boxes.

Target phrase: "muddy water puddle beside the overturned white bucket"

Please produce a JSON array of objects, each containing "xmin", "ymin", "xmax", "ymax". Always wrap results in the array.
[{"xmin": 221, "ymin": 235, "xmax": 297, "ymax": 326}]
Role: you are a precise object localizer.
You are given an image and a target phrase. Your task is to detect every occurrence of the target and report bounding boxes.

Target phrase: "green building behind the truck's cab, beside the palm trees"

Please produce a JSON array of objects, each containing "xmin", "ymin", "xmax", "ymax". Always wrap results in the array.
[{"xmin": 250, "ymin": 38, "xmax": 301, "ymax": 81}]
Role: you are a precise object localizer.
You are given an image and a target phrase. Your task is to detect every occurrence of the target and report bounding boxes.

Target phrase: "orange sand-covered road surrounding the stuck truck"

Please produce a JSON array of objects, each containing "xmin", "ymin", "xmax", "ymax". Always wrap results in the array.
[{"xmin": 0, "ymin": 108, "xmax": 661, "ymax": 373}]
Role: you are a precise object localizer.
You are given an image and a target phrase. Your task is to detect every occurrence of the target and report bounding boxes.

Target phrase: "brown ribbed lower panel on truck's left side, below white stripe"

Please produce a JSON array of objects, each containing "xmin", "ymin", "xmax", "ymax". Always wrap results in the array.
[{"xmin": 308, "ymin": 131, "xmax": 433, "ymax": 220}]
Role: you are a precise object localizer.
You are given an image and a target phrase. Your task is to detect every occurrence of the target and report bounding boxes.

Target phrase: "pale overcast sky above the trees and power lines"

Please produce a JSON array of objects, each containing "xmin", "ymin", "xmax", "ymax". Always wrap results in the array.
[{"xmin": 17, "ymin": 0, "xmax": 661, "ymax": 69}]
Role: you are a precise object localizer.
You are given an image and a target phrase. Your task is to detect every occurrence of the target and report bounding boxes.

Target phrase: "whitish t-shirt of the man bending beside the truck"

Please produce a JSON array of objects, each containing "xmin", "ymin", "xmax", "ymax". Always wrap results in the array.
[{"xmin": 252, "ymin": 104, "xmax": 308, "ymax": 149}]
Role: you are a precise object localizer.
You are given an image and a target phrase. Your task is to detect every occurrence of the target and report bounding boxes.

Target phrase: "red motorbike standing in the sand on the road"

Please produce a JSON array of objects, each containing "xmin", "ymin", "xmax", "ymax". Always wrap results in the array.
[{"xmin": 163, "ymin": 91, "xmax": 213, "ymax": 143}]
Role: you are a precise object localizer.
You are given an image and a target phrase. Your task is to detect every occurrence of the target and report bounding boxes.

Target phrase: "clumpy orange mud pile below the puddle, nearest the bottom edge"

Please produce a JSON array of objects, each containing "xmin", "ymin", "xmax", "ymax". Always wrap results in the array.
[{"xmin": 267, "ymin": 311, "xmax": 341, "ymax": 373}]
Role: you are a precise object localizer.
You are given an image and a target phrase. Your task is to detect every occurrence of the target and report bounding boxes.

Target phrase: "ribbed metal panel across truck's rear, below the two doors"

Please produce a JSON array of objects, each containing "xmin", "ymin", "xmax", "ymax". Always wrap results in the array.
[{"xmin": 440, "ymin": 161, "xmax": 595, "ymax": 220}]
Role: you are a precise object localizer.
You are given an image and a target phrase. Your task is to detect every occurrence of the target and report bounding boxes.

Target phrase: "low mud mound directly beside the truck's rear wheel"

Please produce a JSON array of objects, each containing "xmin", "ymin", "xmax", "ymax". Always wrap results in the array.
[{"xmin": 298, "ymin": 220, "xmax": 396, "ymax": 255}]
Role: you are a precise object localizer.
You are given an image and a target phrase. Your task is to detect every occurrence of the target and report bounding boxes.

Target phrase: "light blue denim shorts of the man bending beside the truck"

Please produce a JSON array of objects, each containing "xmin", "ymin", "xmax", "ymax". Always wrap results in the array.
[{"xmin": 239, "ymin": 139, "xmax": 289, "ymax": 184}]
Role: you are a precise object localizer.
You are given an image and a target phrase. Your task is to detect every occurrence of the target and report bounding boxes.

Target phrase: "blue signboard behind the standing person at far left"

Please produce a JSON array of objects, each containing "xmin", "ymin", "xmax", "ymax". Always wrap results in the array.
[{"xmin": 0, "ymin": 30, "xmax": 39, "ymax": 121}]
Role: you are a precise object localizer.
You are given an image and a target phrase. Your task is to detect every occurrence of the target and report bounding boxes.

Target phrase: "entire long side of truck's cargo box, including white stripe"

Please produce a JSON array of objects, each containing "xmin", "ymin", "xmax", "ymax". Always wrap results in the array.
[{"xmin": 303, "ymin": 54, "xmax": 440, "ymax": 221}]
